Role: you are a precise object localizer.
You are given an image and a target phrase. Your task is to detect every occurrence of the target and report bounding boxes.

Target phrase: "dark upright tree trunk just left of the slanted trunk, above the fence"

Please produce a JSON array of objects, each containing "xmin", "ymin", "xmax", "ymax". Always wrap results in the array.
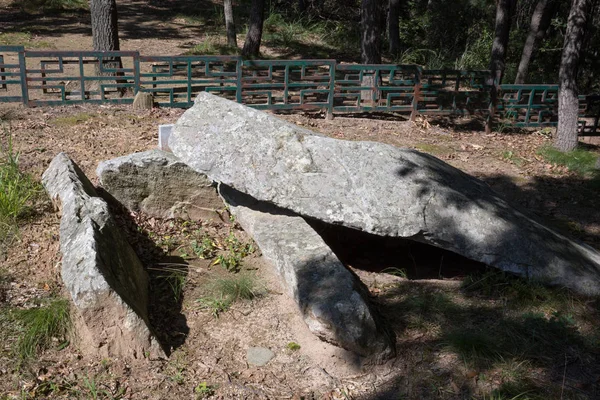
[{"xmin": 490, "ymin": 0, "xmax": 517, "ymax": 85}]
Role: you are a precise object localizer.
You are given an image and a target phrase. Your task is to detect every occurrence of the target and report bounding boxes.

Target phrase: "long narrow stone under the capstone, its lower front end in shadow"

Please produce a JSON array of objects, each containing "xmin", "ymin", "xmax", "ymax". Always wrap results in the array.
[{"xmin": 220, "ymin": 185, "xmax": 395, "ymax": 363}]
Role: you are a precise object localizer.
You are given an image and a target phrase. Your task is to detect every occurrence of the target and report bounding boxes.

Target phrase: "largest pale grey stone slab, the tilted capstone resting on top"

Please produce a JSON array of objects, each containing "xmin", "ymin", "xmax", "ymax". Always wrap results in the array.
[{"xmin": 170, "ymin": 93, "xmax": 600, "ymax": 294}]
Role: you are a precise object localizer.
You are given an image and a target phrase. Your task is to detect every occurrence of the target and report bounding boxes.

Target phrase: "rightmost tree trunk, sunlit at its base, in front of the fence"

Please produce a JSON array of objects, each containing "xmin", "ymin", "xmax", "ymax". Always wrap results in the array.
[{"xmin": 554, "ymin": 0, "xmax": 592, "ymax": 151}]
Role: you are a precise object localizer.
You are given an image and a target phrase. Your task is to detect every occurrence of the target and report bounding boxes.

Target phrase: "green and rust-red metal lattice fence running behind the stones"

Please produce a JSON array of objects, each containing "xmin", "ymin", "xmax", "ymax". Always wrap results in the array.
[{"xmin": 0, "ymin": 46, "xmax": 600, "ymax": 136}]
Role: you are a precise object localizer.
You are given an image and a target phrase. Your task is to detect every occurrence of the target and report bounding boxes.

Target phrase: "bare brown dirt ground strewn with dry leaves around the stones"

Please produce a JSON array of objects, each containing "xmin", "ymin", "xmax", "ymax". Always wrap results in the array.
[{"xmin": 0, "ymin": 0, "xmax": 600, "ymax": 399}]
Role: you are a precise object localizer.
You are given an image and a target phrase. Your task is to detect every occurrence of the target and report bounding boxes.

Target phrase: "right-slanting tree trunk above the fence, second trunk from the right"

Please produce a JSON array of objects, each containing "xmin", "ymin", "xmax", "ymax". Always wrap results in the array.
[{"xmin": 515, "ymin": 0, "xmax": 554, "ymax": 85}]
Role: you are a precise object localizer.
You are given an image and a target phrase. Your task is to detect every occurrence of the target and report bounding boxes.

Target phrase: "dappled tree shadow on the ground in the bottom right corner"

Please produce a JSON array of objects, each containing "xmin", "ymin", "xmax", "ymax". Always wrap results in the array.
[{"xmin": 358, "ymin": 279, "xmax": 600, "ymax": 400}]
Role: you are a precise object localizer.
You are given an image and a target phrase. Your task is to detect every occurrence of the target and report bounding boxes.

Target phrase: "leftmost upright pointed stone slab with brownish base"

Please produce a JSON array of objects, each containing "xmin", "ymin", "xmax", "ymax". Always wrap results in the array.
[{"xmin": 42, "ymin": 153, "xmax": 164, "ymax": 358}]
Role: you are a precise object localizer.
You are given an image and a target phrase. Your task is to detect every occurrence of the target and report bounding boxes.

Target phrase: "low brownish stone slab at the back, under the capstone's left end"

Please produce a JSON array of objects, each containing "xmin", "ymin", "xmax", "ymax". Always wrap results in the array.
[{"xmin": 96, "ymin": 150, "xmax": 223, "ymax": 219}]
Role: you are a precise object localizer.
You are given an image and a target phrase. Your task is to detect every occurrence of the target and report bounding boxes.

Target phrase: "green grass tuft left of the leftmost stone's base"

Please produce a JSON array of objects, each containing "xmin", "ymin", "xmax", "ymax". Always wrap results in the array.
[{"xmin": 12, "ymin": 299, "xmax": 71, "ymax": 360}]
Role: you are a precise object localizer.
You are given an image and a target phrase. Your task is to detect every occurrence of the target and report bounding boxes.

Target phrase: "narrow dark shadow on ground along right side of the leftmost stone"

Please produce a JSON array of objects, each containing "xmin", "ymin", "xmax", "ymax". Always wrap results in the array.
[{"xmin": 96, "ymin": 188, "xmax": 190, "ymax": 355}]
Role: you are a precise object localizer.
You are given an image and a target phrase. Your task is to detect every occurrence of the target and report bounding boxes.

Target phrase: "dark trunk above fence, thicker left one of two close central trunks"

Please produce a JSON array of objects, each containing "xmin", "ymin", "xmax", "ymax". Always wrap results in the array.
[{"xmin": 360, "ymin": 0, "xmax": 381, "ymax": 64}]
